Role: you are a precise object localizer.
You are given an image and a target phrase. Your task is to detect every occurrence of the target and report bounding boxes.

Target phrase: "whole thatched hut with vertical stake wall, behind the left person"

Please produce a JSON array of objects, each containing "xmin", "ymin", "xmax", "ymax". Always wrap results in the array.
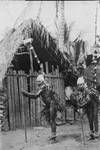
[{"xmin": 0, "ymin": 19, "xmax": 76, "ymax": 129}]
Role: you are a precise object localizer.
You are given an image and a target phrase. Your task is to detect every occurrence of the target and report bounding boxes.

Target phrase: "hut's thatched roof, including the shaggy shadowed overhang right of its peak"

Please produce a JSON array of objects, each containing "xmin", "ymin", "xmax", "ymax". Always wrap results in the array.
[{"xmin": 0, "ymin": 19, "xmax": 69, "ymax": 81}]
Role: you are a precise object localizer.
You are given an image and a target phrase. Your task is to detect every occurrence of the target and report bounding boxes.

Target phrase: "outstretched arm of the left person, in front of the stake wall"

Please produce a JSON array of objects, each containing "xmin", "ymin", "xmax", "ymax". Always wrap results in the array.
[{"xmin": 22, "ymin": 89, "xmax": 41, "ymax": 99}]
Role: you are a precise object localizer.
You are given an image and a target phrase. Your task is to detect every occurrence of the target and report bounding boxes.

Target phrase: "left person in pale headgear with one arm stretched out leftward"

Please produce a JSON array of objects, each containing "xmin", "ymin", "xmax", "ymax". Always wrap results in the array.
[{"xmin": 22, "ymin": 74, "xmax": 63, "ymax": 143}]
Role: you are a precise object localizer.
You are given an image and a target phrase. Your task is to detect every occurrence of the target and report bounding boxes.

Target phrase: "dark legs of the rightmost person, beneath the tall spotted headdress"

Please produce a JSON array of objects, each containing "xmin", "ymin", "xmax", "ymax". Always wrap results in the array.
[{"xmin": 86, "ymin": 99, "xmax": 98, "ymax": 132}]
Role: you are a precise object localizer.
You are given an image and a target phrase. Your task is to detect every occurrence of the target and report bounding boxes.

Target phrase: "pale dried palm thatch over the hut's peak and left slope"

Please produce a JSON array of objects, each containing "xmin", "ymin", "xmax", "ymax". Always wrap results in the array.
[{"xmin": 0, "ymin": 19, "xmax": 59, "ymax": 83}]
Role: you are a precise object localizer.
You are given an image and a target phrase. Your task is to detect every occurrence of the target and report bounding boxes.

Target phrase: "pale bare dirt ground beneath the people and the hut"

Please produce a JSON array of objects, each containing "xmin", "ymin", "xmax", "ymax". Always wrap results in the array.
[{"xmin": 0, "ymin": 121, "xmax": 100, "ymax": 150}]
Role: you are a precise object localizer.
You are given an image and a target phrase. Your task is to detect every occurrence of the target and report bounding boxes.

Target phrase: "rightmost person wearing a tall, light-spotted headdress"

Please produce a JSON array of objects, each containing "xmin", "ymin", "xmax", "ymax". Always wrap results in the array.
[{"xmin": 87, "ymin": 50, "xmax": 99, "ymax": 139}]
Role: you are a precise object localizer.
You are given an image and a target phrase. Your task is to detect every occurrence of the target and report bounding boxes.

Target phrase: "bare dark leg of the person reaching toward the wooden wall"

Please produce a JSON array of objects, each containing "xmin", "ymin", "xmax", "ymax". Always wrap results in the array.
[{"xmin": 50, "ymin": 101, "xmax": 57, "ymax": 137}]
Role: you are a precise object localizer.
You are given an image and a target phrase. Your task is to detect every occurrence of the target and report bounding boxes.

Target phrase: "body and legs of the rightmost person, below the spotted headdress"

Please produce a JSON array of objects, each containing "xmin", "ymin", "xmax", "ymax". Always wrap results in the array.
[{"xmin": 86, "ymin": 88, "xmax": 99, "ymax": 140}]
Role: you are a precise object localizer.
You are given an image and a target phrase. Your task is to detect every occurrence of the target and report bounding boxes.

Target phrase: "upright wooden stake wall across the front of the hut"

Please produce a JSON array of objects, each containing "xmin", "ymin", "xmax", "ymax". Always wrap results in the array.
[{"xmin": 6, "ymin": 65, "xmax": 64, "ymax": 130}]
